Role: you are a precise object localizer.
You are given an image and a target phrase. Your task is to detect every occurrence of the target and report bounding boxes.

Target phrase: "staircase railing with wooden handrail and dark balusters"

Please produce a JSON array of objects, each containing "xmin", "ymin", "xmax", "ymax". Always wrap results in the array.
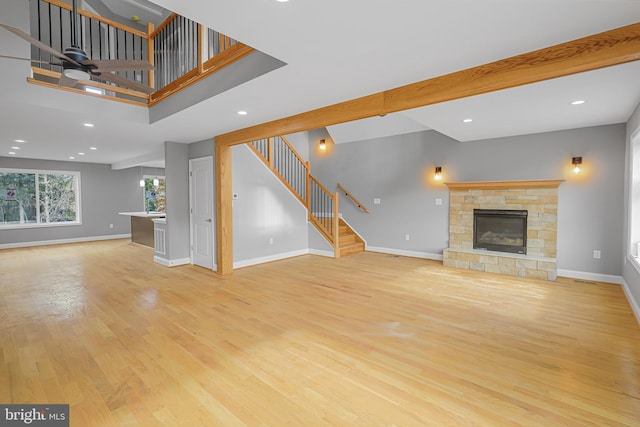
[{"xmin": 247, "ymin": 136, "xmax": 339, "ymax": 254}]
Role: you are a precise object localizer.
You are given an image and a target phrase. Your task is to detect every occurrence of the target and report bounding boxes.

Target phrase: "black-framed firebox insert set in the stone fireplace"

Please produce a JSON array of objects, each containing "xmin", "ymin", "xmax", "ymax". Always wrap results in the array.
[{"xmin": 473, "ymin": 209, "xmax": 527, "ymax": 254}]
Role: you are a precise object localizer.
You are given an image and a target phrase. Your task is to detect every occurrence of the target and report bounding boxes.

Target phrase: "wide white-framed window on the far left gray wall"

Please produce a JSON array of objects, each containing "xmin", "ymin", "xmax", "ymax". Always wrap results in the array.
[{"xmin": 0, "ymin": 169, "xmax": 80, "ymax": 228}]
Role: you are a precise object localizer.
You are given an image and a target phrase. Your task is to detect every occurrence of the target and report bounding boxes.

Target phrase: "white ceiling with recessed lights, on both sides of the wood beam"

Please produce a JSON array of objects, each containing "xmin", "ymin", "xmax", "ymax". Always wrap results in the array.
[{"xmin": 0, "ymin": 0, "xmax": 640, "ymax": 167}]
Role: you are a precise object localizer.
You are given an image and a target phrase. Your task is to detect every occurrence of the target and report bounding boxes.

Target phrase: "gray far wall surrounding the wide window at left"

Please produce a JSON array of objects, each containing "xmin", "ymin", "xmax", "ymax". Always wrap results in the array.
[{"xmin": 0, "ymin": 157, "xmax": 144, "ymax": 244}]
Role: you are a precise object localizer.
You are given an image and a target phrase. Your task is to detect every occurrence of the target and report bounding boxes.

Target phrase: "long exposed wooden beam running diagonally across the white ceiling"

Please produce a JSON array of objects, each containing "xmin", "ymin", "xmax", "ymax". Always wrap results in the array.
[{"xmin": 216, "ymin": 23, "xmax": 640, "ymax": 145}]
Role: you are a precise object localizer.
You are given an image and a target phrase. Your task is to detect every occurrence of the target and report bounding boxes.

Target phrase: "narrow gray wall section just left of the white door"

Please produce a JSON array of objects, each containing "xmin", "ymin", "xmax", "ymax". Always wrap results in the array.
[{"xmin": 164, "ymin": 142, "xmax": 191, "ymax": 261}]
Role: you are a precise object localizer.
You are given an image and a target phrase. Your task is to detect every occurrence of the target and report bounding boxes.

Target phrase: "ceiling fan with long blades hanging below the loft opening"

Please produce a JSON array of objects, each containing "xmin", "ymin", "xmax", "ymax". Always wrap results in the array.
[{"xmin": 0, "ymin": 0, "xmax": 155, "ymax": 94}]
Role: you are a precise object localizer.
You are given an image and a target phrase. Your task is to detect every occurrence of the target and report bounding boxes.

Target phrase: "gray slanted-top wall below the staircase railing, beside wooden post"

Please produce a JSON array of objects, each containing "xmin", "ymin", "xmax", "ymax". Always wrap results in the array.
[{"xmin": 232, "ymin": 145, "xmax": 309, "ymax": 265}]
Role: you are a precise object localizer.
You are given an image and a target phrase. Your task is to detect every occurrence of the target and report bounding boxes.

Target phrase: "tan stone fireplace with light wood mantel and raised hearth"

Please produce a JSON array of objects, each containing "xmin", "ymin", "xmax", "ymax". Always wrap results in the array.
[{"xmin": 443, "ymin": 180, "xmax": 562, "ymax": 280}]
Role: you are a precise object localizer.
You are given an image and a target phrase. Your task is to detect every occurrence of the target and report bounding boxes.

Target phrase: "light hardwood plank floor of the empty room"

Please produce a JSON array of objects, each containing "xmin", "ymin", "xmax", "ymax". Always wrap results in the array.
[{"xmin": 0, "ymin": 240, "xmax": 640, "ymax": 427}]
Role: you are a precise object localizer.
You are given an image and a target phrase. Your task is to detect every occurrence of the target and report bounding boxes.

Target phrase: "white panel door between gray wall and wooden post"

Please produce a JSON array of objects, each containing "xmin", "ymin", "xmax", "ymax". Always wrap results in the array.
[{"xmin": 189, "ymin": 157, "xmax": 215, "ymax": 269}]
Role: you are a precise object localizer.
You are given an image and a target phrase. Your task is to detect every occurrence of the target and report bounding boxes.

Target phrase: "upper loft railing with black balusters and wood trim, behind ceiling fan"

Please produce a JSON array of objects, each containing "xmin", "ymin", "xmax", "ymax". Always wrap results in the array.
[{"xmin": 29, "ymin": 0, "xmax": 253, "ymax": 105}]
